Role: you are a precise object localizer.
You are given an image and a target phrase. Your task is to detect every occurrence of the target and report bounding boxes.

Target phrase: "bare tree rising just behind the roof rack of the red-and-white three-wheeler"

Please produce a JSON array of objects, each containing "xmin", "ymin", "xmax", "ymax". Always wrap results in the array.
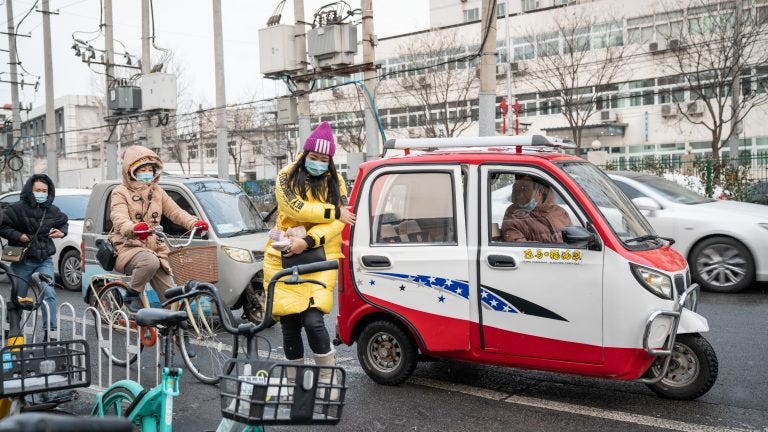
[{"xmin": 382, "ymin": 31, "xmax": 477, "ymax": 137}]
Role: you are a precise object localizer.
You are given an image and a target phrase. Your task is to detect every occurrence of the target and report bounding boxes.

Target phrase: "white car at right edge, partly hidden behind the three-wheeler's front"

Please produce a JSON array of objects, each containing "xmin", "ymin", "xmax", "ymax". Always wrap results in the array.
[{"xmin": 609, "ymin": 172, "xmax": 768, "ymax": 292}]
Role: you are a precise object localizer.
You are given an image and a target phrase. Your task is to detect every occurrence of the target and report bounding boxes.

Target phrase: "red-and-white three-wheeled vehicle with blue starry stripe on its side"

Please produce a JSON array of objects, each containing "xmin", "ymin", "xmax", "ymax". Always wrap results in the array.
[{"xmin": 335, "ymin": 135, "xmax": 717, "ymax": 399}]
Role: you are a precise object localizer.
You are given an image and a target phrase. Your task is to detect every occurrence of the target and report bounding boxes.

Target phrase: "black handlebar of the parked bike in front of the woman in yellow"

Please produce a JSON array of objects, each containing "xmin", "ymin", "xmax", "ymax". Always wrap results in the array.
[{"xmin": 179, "ymin": 260, "xmax": 339, "ymax": 336}]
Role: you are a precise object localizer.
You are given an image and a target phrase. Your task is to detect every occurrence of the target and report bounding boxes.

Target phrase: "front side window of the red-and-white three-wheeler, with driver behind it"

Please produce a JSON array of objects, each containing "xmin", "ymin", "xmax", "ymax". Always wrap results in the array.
[{"xmin": 488, "ymin": 171, "xmax": 583, "ymax": 246}]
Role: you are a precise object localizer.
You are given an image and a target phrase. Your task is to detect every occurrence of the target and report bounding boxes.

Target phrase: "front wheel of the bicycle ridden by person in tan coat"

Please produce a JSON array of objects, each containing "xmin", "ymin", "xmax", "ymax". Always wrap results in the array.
[{"xmin": 179, "ymin": 293, "xmax": 237, "ymax": 384}]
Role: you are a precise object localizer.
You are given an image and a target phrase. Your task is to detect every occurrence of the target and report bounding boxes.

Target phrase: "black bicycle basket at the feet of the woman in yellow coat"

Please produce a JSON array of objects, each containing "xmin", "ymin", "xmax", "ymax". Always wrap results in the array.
[{"xmin": 220, "ymin": 360, "xmax": 346, "ymax": 425}]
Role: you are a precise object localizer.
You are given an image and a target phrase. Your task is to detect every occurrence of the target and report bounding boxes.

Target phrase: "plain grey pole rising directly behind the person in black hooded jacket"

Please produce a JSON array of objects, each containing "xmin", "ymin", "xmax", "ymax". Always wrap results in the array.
[{"xmin": 42, "ymin": 0, "xmax": 59, "ymax": 185}]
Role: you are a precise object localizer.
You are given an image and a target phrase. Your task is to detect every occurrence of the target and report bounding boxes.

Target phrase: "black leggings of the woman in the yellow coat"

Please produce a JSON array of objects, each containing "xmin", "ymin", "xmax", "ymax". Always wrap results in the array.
[{"xmin": 280, "ymin": 308, "xmax": 331, "ymax": 360}]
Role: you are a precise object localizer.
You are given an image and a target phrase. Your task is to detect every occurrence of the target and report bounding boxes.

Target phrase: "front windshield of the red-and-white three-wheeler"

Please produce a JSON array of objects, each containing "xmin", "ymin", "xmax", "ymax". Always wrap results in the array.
[{"xmin": 560, "ymin": 162, "xmax": 663, "ymax": 249}]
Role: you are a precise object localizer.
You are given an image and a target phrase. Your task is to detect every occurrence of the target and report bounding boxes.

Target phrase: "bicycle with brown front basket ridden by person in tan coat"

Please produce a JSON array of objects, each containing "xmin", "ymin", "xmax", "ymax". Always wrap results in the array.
[{"xmin": 91, "ymin": 226, "xmax": 238, "ymax": 384}]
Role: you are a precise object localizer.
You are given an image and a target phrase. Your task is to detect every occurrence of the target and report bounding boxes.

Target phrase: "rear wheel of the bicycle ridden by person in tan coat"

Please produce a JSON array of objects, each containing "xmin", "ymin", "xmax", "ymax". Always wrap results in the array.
[{"xmin": 92, "ymin": 281, "xmax": 144, "ymax": 366}]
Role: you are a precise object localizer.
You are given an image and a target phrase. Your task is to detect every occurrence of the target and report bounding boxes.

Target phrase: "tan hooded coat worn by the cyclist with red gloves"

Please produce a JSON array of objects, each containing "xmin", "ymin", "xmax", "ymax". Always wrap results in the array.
[{"xmin": 109, "ymin": 145, "xmax": 197, "ymax": 274}]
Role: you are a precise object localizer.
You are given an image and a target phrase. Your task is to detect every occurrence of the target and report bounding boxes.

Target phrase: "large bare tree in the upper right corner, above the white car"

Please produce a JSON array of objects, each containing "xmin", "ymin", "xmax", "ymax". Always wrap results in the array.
[{"xmin": 667, "ymin": 0, "xmax": 768, "ymax": 160}]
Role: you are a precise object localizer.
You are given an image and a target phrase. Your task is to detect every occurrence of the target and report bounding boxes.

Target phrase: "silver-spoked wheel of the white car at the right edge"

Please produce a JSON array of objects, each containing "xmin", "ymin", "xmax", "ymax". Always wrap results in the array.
[{"xmin": 689, "ymin": 237, "xmax": 755, "ymax": 293}]
